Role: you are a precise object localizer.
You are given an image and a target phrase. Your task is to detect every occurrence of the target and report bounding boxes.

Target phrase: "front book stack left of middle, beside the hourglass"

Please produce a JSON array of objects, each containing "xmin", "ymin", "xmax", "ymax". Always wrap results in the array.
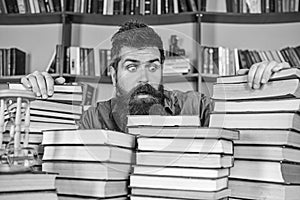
[{"xmin": 42, "ymin": 129, "xmax": 135, "ymax": 200}]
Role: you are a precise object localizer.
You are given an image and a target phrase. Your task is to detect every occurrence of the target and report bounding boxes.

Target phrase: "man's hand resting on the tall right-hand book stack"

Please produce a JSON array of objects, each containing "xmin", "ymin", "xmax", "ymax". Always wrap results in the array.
[{"xmin": 237, "ymin": 61, "xmax": 291, "ymax": 89}]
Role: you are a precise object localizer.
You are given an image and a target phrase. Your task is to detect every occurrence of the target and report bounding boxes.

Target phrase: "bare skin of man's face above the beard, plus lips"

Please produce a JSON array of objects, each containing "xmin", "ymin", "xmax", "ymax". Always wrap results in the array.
[{"xmin": 116, "ymin": 47, "xmax": 162, "ymax": 98}]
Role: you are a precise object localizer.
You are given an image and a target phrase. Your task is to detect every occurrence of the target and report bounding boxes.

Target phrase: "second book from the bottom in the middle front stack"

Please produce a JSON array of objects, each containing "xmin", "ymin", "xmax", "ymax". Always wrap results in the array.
[{"xmin": 130, "ymin": 174, "xmax": 228, "ymax": 192}]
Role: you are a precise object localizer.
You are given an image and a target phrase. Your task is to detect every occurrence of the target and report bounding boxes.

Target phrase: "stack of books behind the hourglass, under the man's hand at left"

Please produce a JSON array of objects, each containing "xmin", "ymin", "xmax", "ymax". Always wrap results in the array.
[{"xmin": 1, "ymin": 83, "xmax": 83, "ymax": 171}]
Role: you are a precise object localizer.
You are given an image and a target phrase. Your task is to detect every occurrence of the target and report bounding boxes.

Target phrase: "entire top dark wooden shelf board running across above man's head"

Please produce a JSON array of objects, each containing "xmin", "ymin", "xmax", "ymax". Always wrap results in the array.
[{"xmin": 0, "ymin": 12, "xmax": 300, "ymax": 26}]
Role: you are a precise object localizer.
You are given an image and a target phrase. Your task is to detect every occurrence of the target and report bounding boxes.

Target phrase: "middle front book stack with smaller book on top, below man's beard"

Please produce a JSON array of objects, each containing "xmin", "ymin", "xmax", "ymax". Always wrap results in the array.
[{"xmin": 128, "ymin": 115, "xmax": 239, "ymax": 200}]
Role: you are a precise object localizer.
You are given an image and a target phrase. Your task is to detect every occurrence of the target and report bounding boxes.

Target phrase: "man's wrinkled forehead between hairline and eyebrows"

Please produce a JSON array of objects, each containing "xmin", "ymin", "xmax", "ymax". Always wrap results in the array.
[{"xmin": 119, "ymin": 47, "xmax": 160, "ymax": 61}]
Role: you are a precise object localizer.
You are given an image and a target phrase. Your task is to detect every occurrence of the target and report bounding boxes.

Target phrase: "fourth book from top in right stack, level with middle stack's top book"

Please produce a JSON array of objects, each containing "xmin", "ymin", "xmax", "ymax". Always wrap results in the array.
[{"xmin": 209, "ymin": 113, "xmax": 300, "ymax": 131}]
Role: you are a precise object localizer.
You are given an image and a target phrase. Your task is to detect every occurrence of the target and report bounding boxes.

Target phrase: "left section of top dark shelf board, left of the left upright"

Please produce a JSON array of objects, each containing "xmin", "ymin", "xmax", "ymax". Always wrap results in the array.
[{"xmin": 0, "ymin": 12, "xmax": 62, "ymax": 25}]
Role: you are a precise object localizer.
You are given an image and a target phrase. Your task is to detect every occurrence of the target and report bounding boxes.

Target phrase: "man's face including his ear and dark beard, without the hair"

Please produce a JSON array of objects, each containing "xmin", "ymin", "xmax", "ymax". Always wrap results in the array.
[{"xmin": 113, "ymin": 47, "xmax": 164, "ymax": 115}]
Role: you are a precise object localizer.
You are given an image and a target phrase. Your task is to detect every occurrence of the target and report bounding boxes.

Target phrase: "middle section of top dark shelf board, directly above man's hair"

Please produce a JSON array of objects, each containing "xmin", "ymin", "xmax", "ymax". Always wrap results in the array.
[{"xmin": 66, "ymin": 12, "xmax": 199, "ymax": 26}]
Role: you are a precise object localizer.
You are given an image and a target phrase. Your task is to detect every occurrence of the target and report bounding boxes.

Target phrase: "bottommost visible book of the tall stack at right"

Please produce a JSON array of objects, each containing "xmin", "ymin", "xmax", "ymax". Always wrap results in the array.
[{"xmin": 229, "ymin": 179, "xmax": 300, "ymax": 200}]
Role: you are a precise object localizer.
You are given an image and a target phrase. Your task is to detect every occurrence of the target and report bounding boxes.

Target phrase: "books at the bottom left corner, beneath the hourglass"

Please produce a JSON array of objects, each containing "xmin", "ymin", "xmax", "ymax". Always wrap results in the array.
[{"xmin": 0, "ymin": 172, "xmax": 58, "ymax": 200}]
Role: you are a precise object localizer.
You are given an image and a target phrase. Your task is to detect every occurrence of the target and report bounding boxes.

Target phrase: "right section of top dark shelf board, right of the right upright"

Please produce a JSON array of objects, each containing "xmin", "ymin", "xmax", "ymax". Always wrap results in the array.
[{"xmin": 201, "ymin": 12, "xmax": 300, "ymax": 24}]
